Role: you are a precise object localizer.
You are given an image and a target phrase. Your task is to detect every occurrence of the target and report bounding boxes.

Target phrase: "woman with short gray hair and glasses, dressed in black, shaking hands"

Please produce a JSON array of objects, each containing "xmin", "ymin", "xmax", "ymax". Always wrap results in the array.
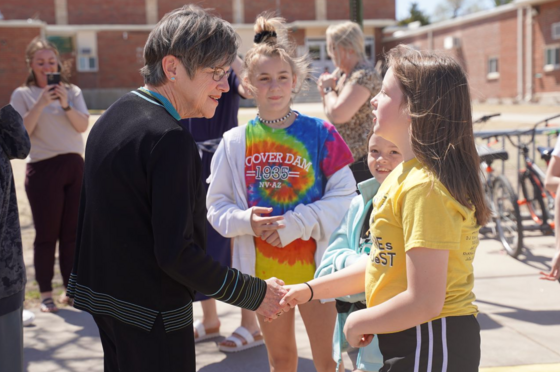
[{"xmin": 68, "ymin": 6, "xmax": 288, "ymax": 372}]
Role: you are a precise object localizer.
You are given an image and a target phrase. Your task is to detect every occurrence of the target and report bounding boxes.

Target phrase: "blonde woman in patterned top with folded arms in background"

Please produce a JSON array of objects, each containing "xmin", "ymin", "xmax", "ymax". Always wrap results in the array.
[{"xmin": 318, "ymin": 21, "xmax": 381, "ymax": 183}]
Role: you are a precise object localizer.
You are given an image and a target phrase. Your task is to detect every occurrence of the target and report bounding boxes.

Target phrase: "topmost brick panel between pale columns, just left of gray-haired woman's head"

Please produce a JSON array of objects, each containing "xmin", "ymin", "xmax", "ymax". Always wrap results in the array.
[{"xmin": 67, "ymin": 0, "xmax": 146, "ymax": 25}]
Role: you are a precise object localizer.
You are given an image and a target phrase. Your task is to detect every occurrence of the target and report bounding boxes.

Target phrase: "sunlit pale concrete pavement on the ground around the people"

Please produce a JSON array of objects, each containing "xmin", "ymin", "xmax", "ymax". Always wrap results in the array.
[{"xmin": 21, "ymin": 231, "xmax": 560, "ymax": 372}]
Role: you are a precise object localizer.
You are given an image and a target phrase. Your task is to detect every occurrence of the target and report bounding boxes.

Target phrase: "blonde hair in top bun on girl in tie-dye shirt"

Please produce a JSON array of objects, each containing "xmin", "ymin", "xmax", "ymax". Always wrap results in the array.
[{"xmin": 243, "ymin": 12, "xmax": 311, "ymax": 94}]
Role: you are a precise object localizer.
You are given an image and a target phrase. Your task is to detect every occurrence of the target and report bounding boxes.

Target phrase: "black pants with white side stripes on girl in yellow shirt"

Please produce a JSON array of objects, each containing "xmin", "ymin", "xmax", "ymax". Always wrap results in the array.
[{"xmin": 378, "ymin": 315, "xmax": 480, "ymax": 372}]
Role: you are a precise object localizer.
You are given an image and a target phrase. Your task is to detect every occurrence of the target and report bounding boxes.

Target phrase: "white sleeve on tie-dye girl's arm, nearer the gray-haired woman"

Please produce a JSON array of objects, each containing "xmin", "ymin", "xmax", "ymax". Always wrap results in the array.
[{"xmin": 206, "ymin": 140, "xmax": 254, "ymax": 238}]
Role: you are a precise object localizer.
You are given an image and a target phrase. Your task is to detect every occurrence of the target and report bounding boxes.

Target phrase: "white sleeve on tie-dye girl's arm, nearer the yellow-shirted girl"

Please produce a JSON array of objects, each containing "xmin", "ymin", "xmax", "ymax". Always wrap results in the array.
[{"xmin": 278, "ymin": 166, "xmax": 356, "ymax": 247}]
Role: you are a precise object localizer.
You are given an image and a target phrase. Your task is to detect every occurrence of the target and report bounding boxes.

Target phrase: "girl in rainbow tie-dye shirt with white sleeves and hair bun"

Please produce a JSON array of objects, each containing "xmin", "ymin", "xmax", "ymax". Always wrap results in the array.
[{"xmin": 207, "ymin": 11, "xmax": 356, "ymax": 372}]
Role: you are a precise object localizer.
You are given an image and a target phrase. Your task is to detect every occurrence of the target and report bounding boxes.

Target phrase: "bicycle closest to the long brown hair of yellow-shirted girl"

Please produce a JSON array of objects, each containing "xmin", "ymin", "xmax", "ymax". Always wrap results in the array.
[{"xmin": 473, "ymin": 114, "xmax": 523, "ymax": 257}]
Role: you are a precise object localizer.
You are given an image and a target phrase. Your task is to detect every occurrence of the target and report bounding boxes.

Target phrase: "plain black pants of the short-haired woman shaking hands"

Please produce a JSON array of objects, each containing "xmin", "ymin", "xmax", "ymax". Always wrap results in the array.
[{"xmin": 93, "ymin": 315, "xmax": 196, "ymax": 372}]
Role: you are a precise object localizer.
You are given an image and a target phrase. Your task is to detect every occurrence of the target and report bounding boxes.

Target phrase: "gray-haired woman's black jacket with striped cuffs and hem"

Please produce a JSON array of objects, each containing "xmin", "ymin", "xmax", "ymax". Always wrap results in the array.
[{"xmin": 68, "ymin": 91, "xmax": 266, "ymax": 332}]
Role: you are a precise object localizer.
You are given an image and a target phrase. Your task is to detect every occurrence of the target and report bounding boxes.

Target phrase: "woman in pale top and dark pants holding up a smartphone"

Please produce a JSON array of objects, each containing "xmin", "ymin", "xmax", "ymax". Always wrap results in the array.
[{"xmin": 10, "ymin": 37, "xmax": 89, "ymax": 312}]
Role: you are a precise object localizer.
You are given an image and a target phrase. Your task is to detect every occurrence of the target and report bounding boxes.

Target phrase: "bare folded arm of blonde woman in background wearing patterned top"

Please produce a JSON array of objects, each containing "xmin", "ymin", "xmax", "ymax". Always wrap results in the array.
[{"xmin": 321, "ymin": 79, "xmax": 370, "ymax": 124}]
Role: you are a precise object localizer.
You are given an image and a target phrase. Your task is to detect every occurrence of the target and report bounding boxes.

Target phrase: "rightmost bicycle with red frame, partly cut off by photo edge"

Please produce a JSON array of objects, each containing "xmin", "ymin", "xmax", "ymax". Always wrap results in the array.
[{"xmin": 505, "ymin": 115, "xmax": 560, "ymax": 235}]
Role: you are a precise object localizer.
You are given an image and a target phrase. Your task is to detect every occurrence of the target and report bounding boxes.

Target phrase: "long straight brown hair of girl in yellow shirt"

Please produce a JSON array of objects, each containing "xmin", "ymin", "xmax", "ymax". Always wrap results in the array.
[{"xmin": 387, "ymin": 45, "xmax": 490, "ymax": 225}]
